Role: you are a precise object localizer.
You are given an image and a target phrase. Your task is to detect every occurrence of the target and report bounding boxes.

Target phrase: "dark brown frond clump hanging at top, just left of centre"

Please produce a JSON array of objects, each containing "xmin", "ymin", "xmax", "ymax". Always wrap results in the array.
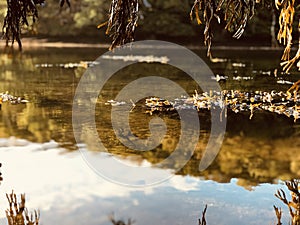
[{"xmin": 98, "ymin": 0, "xmax": 139, "ymax": 50}]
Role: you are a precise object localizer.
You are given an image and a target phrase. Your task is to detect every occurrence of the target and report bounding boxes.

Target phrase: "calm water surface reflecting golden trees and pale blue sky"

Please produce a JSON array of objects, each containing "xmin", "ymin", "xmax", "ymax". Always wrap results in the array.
[{"xmin": 0, "ymin": 48, "xmax": 300, "ymax": 225}]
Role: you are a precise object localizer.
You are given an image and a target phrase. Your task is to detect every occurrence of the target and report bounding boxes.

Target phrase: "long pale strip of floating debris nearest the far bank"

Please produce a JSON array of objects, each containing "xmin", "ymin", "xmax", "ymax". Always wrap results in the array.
[{"xmin": 101, "ymin": 55, "xmax": 170, "ymax": 64}]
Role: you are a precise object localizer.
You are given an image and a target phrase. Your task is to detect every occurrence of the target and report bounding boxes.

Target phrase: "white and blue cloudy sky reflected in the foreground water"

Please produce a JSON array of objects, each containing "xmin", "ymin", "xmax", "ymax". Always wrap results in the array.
[{"xmin": 0, "ymin": 139, "xmax": 288, "ymax": 225}]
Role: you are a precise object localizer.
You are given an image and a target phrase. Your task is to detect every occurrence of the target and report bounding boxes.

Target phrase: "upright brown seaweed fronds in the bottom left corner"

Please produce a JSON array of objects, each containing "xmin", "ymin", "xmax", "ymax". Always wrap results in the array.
[{"xmin": 5, "ymin": 191, "xmax": 40, "ymax": 225}]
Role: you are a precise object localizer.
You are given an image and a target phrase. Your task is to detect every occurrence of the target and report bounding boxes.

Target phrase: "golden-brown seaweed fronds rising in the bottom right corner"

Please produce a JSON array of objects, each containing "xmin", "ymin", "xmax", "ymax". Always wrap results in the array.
[{"xmin": 274, "ymin": 179, "xmax": 300, "ymax": 225}]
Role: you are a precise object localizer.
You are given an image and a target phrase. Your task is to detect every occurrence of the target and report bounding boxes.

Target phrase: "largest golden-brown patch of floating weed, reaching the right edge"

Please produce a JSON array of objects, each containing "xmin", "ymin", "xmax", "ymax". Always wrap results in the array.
[{"xmin": 145, "ymin": 90, "xmax": 300, "ymax": 122}]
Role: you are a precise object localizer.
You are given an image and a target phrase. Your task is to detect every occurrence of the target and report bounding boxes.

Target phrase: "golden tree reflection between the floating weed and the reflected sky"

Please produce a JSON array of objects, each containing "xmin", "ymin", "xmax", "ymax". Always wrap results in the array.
[{"xmin": 0, "ymin": 91, "xmax": 300, "ymax": 189}]
